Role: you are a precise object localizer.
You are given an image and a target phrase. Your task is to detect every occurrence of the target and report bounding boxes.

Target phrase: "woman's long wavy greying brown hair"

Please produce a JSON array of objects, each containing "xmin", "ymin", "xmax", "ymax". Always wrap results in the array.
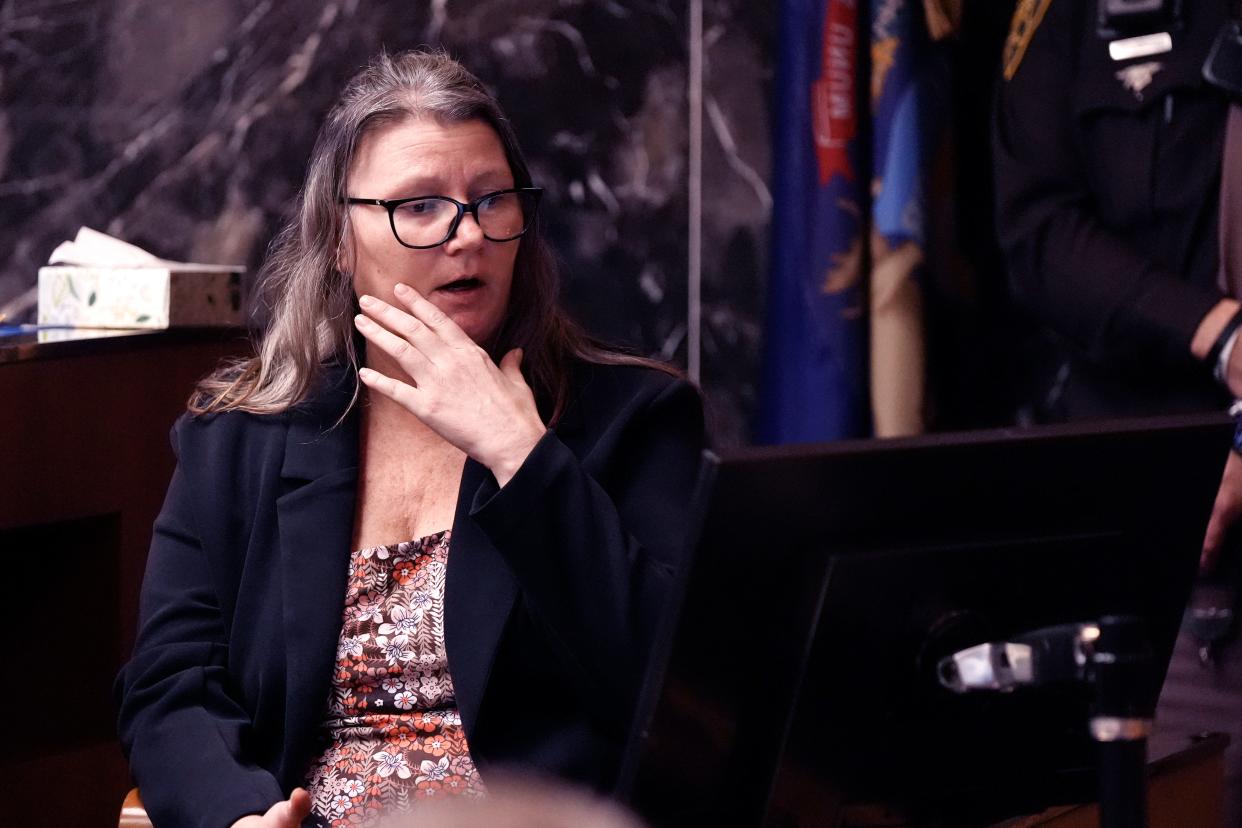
[{"xmin": 189, "ymin": 51, "xmax": 677, "ymax": 422}]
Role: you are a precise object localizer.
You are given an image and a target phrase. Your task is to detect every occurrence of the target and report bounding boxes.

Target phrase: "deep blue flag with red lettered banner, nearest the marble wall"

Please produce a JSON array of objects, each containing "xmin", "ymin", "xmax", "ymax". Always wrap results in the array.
[{"xmin": 756, "ymin": 0, "xmax": 869, "ymax": 443}]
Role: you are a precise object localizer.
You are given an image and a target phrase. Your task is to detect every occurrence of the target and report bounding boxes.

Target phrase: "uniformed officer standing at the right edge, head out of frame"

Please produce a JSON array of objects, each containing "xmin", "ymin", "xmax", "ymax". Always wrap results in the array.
[{"xmin": 994, "ymin": 0, "xmax": 1242, "ymax": 824}]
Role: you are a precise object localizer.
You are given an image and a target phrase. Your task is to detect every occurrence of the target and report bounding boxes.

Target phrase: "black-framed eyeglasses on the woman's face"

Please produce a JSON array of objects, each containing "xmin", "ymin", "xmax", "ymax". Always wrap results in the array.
[{"xmin": 345, "ymin": 187, "xmax": 543, "ymax": 250}]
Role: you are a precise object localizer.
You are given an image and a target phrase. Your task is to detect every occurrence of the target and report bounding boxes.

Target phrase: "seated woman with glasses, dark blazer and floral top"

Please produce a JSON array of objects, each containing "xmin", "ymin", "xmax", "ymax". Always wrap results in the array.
[{"xmin": 118, "ymin": 52, "xmax": 703, "ymax": 827}]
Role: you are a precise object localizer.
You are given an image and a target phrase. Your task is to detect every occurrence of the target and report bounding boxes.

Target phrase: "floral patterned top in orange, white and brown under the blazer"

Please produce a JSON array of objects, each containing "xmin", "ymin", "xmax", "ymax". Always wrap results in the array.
[{"xmin": 307, "ymin": 530, "xmax": 484, "ymax": 828}]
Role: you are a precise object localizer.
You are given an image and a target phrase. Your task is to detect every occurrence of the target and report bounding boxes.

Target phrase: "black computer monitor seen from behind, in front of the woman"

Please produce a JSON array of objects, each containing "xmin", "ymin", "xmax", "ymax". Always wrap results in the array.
[{"xmin": 621, "ymin": 415, "xmax": 1232, "ymax": 826}]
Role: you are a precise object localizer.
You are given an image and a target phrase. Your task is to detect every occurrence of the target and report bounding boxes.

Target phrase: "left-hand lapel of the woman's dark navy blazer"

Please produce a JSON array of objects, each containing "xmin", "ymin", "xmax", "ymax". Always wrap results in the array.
[{"xmin": 276, "ymin": 371, "xmax": 358, "ymax": 772}]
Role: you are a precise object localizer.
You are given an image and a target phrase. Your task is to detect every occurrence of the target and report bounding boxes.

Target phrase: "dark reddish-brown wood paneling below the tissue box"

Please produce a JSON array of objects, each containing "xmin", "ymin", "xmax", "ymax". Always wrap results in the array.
[{"xmin": 0, "ymin": 331, "xmax": 246, "ymax": 827}]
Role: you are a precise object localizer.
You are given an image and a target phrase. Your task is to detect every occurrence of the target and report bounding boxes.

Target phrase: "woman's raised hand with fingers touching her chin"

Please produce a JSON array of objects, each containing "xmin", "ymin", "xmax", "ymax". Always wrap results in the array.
[{"xmin": 354, "ymin": 284, "xmax": 546, "ymax": 487}]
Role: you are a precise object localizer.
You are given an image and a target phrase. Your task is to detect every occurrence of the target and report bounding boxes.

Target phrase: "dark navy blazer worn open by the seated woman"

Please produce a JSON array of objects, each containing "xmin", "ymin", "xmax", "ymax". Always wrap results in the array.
[{"xmin": 117, "ymin": 365, "xmax": 703, "ymax": 828}]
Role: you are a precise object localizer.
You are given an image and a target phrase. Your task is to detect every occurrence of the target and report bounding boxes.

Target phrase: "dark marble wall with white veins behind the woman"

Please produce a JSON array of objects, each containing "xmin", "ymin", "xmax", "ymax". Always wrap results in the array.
[{"xmin": 0, "ymin": 0, "xmax": 776, "ymax": 444}]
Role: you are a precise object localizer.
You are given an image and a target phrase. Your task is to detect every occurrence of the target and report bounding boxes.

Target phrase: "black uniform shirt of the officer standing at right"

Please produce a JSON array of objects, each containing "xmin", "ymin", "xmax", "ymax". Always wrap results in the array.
[{"xmin": 994, "ymin": 0, "xmax": 1228, "ymax": 416}]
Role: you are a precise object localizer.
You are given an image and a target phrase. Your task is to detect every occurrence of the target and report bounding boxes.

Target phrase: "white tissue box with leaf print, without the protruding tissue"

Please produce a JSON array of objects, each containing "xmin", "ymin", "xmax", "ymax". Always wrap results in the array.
[{"xmin": 39, "ymin": 264, "xmax": 243, "ymax": 328}]
